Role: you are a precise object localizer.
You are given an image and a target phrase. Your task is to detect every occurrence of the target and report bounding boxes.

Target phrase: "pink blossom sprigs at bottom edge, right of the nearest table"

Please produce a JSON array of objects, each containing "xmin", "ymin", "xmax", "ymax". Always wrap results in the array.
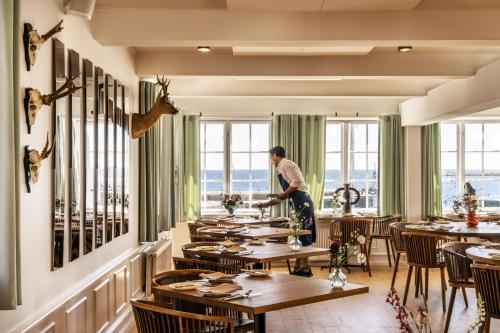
[{"xmin": 385, "ymin": 288, "xmax": 432, "ymax": 333}]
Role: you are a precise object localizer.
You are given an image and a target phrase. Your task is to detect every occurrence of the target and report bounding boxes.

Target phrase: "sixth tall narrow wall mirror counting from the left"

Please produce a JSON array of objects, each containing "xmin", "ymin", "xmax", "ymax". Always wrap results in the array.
[{"xmin": 114, "ymin": 81, "xmax": 124, "ymax": 237}]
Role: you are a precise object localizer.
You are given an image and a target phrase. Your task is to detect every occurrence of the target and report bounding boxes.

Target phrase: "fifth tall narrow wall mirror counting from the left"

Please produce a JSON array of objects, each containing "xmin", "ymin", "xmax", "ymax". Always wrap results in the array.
[{"xmin": 104, "ymin": 74, "xmax": 116, "ymax": 242}]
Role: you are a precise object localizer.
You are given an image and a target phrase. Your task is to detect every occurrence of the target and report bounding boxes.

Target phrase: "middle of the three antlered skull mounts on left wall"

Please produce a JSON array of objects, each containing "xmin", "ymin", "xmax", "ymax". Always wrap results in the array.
[{"xmin": 24, "ymin": 77, "xmax": 83, "ymax": 133}]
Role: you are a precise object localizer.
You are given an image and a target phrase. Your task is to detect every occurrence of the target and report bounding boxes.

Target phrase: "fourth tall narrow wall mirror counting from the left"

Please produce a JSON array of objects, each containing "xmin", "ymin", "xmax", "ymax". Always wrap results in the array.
[{"xmin": 94, "ymin": 67, "xmax": 106, "ymax": 248}]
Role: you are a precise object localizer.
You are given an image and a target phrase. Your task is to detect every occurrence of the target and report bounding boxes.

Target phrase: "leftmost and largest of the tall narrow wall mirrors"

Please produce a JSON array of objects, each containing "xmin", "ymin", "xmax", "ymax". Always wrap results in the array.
[{"xmin": 52, "ymin": 39, "xmax": 67, "ymax": 270}]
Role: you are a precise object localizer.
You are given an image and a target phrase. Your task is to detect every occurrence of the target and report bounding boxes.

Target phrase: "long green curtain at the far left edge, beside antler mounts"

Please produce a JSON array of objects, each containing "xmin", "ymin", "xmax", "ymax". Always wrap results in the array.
[{"xmin": 0, "ymin": 0, "xmax": 22, "ymax": 310}]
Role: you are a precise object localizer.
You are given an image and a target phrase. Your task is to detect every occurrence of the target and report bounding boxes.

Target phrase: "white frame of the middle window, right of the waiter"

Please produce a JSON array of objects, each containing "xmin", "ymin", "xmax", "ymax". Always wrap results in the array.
[{"xmin": 321, "ymin": 119, "xmax": 380, "ymax": 214}]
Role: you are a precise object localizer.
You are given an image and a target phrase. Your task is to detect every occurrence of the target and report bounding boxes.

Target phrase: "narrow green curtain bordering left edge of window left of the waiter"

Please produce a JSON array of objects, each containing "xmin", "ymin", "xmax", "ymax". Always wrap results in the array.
[{"xmin": 183, "ymin": 115, "xmax": 200, "ymax": 220}]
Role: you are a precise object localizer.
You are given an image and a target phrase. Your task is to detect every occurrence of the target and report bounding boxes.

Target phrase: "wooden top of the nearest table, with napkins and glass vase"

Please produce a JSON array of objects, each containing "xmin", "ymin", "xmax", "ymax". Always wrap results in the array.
[{"xmin": 153, "ymin": 272, "xmax": 368, "ymax": 314}]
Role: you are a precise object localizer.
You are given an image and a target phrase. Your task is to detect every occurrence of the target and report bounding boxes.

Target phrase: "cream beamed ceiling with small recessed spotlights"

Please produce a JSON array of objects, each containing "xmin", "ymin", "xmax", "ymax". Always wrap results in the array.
[{"xmin": 91, "ymin": 0, "xmax": 500, "ymax": 112}]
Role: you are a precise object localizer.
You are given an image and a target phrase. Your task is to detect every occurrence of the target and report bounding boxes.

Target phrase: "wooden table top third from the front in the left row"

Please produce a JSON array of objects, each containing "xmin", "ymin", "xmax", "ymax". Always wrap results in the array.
[{"xmin": 197, "ymin": 226, "xmax": 311, "ymax": 239}]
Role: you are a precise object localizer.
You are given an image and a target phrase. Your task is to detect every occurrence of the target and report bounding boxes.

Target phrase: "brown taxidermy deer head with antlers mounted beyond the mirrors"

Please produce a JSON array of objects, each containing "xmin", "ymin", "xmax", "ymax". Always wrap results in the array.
[{"xmin": 130, "ymin": 76, "xmax": 179, "ymax": 139}]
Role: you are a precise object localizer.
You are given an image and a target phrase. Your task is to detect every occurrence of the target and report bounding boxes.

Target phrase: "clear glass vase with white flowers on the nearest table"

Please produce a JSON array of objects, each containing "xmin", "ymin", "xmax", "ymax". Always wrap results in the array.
[{"xmin": 329, "ymin": 230, "xmax": 366, "ymax": 288}]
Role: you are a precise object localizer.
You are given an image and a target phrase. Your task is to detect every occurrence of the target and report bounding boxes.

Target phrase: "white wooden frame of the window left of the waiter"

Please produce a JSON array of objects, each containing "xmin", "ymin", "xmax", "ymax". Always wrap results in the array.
[{"xmin": 200, "ymin": 119, "xmax": 272, "ymax": 214}]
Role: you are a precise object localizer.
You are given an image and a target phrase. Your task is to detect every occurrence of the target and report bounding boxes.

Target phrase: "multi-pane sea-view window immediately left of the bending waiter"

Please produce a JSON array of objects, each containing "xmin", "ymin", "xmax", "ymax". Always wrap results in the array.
[{"xmin": 200, "ymin": 121, "xmax": 270, "ymax": 212}]
